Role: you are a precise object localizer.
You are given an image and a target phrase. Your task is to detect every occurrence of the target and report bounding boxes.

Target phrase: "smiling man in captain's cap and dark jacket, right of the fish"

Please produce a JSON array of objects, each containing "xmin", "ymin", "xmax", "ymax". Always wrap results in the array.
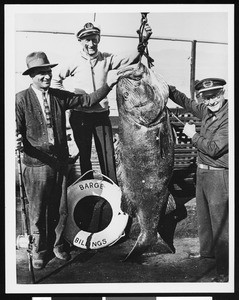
[{"xmin": 169, "ymin": 78, "xmax": 229, "ymax": 281}]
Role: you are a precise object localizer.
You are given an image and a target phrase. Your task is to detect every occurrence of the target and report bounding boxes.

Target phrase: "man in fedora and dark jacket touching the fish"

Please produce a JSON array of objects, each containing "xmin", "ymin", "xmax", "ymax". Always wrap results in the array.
[{"xmin": 16, "ymin": 52, "xmax": 121, "ymax": 269}]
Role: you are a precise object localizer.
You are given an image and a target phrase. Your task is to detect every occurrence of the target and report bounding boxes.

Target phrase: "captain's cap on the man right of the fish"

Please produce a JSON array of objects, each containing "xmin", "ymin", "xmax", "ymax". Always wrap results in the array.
[{"xmin": 195, "ymin": 78, "xmax": 226, "ymax": 94}]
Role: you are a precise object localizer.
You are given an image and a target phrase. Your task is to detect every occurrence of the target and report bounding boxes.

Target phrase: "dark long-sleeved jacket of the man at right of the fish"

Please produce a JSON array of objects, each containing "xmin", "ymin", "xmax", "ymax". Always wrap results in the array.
[{"xmin": 169, "ymin": 86, "xmax": 229, "ymax": 168}]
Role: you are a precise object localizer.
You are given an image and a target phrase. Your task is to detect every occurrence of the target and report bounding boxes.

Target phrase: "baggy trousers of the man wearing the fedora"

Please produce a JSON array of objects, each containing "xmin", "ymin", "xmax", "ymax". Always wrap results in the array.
[{"xmin": 23, "ymin": 165, "xmax": 67, "ymax": 253}]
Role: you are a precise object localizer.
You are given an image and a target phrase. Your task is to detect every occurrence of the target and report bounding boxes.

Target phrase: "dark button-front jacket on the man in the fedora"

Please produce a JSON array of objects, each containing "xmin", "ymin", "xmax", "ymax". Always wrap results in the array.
[{"xmin": 16, "ymin": 84, "xmax": 111, "ymax": 167}]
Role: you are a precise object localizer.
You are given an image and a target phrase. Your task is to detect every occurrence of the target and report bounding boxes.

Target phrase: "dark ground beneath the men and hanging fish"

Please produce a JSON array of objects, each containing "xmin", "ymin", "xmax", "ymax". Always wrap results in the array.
[{"xmin": 16, "ymin": 198, "xmax": 218, "ymax": 284}]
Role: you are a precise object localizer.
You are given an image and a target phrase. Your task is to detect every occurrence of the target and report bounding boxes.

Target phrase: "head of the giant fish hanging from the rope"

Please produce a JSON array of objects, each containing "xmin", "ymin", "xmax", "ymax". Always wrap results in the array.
[{"xmin": 116, "ymin": 63, "xmax": 169, "ymax": 127}]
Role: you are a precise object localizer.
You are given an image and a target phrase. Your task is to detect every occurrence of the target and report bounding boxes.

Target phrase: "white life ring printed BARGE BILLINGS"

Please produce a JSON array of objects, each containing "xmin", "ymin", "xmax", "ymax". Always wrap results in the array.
[{"xmin": 64, "ymin": 171, "xmax": 129, "ymax": 249}]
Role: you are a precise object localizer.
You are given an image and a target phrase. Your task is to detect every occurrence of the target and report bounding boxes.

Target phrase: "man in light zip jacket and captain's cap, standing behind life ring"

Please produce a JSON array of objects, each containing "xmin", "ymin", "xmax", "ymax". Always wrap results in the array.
[{"xmin": 52, "ymin": 22, "xmax": 152, "ymax": 183}]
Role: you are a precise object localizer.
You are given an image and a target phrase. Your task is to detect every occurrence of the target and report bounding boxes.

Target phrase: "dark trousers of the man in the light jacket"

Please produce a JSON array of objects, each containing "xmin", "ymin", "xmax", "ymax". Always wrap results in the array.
[{"xmin": 69, "ymin": 110, "xmax": 117, "ymax": 184}]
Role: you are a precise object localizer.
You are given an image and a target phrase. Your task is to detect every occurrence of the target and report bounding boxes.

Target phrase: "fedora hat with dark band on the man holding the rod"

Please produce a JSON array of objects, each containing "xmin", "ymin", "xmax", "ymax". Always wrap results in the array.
[{"xmin": 22, "ymin": 52, "xmax": 58, "ymax": 75}]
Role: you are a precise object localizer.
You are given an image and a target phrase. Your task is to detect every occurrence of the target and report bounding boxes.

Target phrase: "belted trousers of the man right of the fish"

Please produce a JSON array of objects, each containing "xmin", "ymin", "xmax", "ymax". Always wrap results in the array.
[{"xmin": 196, "ymin": 169, "xmax": 229, "ymax": 275}]
